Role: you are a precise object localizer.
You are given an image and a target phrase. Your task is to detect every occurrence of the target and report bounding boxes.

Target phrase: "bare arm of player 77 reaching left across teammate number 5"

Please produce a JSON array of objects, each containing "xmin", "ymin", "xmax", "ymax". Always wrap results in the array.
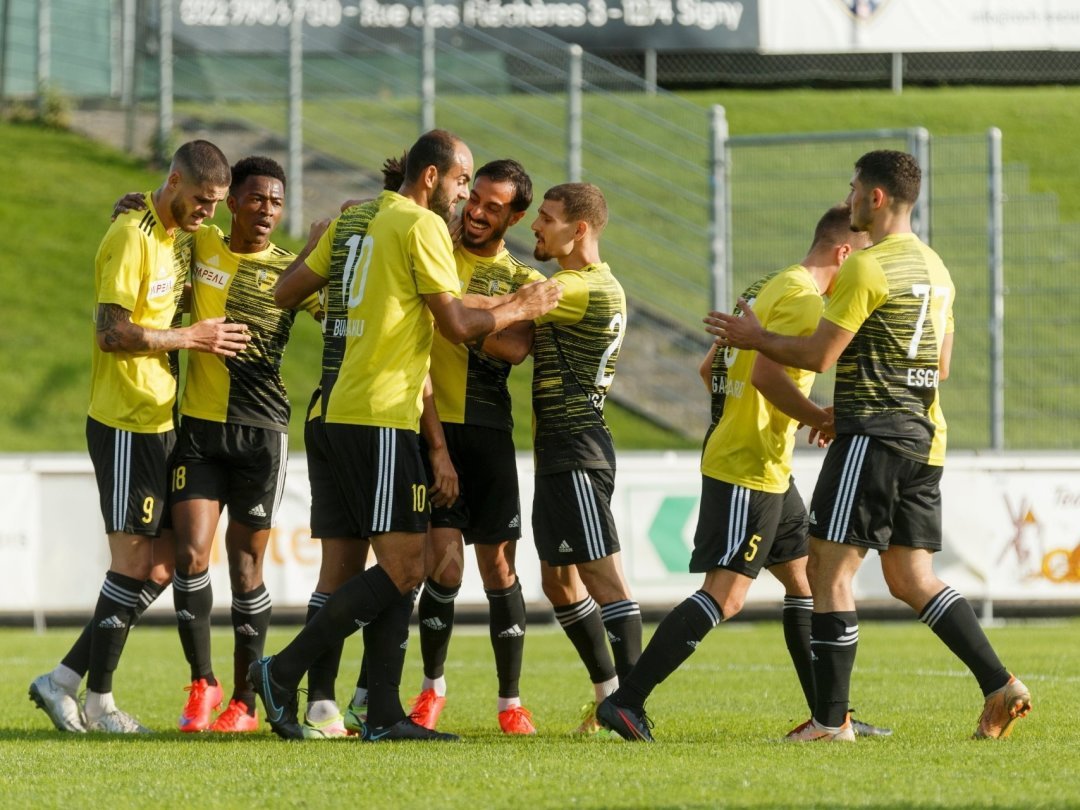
[{"xmin": 704, "ymin": 298, "xmax": 855, "ymax": 372}]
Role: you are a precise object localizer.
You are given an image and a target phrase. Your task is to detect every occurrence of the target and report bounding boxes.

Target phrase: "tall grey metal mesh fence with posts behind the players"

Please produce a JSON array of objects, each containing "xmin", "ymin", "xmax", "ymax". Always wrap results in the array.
[{"xmin": 2, "ymin": 0, "xmax": 1080, "ymax": 448}]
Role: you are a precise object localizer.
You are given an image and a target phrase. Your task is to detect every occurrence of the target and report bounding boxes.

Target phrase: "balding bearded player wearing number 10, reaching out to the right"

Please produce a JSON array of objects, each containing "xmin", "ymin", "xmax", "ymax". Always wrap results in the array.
[{"xmin": 249, "ymin": 130, "xmax": 561, "ymax": 742}]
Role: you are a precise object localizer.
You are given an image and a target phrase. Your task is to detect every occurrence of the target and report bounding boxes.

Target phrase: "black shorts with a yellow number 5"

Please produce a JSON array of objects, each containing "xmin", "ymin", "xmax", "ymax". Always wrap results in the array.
[{"xmin": 690, "ymin": 475, "xmax": 810, "ymax": 579}]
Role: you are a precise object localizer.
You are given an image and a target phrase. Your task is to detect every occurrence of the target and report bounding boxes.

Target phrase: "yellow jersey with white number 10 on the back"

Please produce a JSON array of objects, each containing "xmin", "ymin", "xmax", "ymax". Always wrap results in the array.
[{"xmin": 324, "ymin": 191, "xmax": 461, "ymax": 432}]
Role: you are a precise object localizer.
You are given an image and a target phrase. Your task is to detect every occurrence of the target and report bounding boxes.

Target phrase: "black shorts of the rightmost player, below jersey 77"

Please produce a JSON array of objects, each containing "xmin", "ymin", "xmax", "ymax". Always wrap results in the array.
[{"xmin": 810, "ymin": 435, "xmax": 942, "ymax": 551}]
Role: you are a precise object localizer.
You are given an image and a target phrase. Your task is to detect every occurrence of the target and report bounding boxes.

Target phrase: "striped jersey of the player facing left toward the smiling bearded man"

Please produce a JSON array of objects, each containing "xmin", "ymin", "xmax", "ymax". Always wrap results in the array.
[{"xmin": 532, "ymin": 264, "xmax": 626, "ymax": 474}]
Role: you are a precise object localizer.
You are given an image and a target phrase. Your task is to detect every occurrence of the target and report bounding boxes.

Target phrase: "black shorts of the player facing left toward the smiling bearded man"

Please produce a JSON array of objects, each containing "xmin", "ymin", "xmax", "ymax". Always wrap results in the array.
[{"xmin": 532, "ymin": 470, "xmax": 619, "ymax": 565}]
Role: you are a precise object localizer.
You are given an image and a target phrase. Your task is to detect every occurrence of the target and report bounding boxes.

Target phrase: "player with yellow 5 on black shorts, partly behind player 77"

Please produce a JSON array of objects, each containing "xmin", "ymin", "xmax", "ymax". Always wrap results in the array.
[{"xmin": 596, "ymin": 205, "xmax": 889, "ymax": 741}]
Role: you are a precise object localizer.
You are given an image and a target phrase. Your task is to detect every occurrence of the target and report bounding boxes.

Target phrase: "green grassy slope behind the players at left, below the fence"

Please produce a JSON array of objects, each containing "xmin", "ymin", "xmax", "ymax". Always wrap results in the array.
[{"xmin": 0, "ymin": 124, "xmax": 686, "ymax": 453}]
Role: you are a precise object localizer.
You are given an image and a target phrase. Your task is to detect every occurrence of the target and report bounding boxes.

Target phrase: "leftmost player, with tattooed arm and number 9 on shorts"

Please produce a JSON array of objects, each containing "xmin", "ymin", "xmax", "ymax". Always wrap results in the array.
[{"xmin": 30, "ymin": 140, "xmax": 248, "ymax": 733}]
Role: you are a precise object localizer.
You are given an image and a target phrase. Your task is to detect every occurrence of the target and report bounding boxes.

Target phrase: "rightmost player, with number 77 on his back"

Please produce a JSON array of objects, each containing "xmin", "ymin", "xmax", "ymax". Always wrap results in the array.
[{"xmin": 706, "ymin": 150, "xmax": 1031, "ymax": 742}]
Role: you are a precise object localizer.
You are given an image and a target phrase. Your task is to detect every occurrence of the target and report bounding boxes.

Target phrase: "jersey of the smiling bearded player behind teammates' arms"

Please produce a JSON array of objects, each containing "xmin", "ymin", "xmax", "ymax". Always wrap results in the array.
[{"xmin": 431, "ymin": 247, "xmax": 544, "ymax": 431}]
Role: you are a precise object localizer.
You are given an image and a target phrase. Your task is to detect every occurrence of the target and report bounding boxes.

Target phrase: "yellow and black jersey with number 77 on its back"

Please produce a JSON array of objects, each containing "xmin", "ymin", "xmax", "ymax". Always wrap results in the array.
[{"xmin": 824, "ymin": 233, "xmax": 956, "ymax": 465}]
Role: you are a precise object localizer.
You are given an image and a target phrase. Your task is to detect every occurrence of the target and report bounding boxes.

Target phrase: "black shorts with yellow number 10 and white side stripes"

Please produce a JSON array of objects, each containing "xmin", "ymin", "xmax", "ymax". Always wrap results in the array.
[{"xmin": 323, "ymin": 422, "xmax": 431, "ymax": 538}]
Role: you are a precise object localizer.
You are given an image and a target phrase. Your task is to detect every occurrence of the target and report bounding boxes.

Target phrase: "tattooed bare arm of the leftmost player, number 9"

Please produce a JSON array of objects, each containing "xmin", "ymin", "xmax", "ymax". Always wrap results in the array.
[{"xmin": 97, "ymin": 303, "xmax": 251, "ymax": 357}]
